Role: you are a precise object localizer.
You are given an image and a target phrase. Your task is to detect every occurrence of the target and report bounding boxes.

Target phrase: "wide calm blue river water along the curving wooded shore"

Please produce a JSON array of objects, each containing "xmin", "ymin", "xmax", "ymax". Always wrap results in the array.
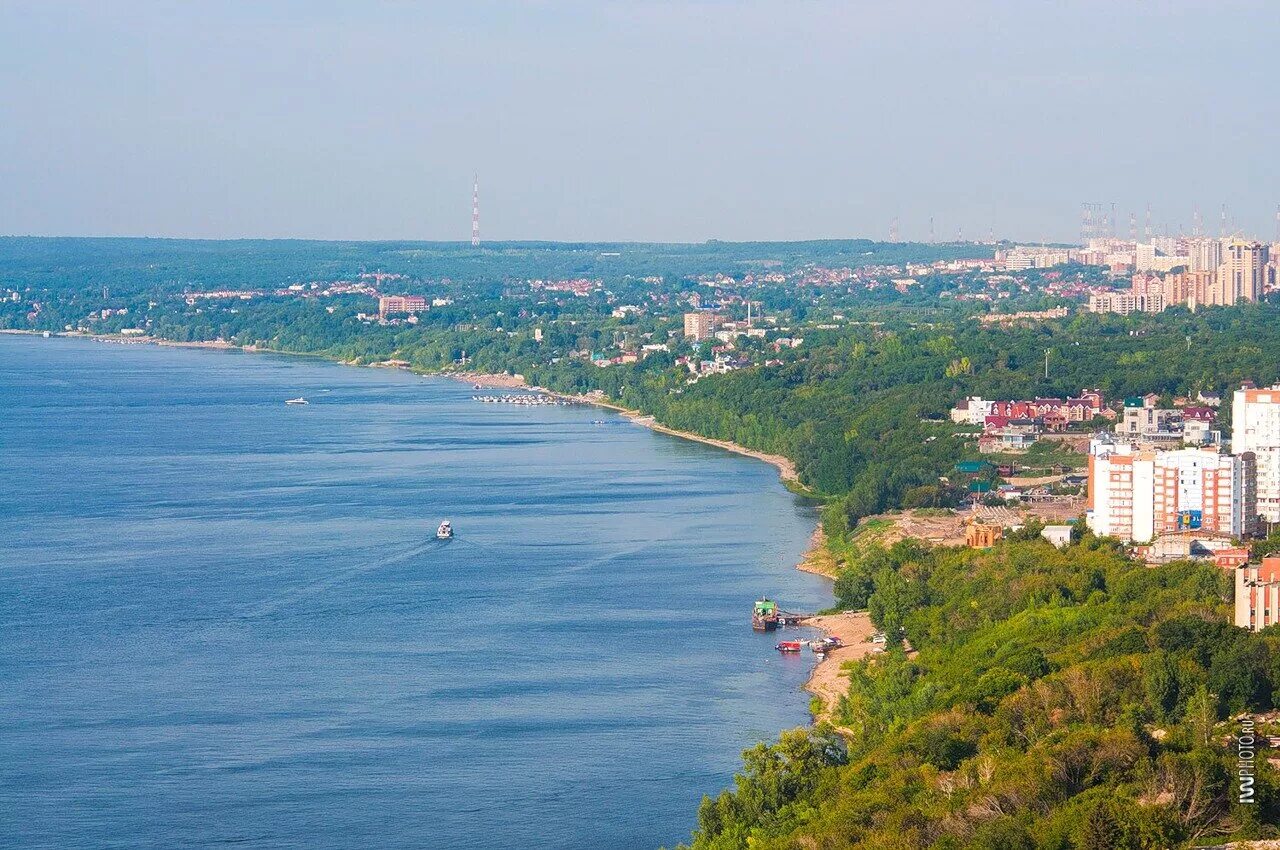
[{"xmin": 0, "ymin": 337, "xmax": 831, "ymax": 849}]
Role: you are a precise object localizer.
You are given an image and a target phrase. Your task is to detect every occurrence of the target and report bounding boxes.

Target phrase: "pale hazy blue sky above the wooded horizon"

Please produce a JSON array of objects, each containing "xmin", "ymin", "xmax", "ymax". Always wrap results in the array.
[{"xmin": 0, "ymin": 0, "xmax": 1280, "ymax": 241}]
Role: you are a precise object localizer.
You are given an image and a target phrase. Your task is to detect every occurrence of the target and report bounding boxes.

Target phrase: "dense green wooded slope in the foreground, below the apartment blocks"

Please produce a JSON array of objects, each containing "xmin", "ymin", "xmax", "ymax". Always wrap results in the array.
[{"xmin": 691, "ymin": 535, "xmax": 1280, "ymax": 850}]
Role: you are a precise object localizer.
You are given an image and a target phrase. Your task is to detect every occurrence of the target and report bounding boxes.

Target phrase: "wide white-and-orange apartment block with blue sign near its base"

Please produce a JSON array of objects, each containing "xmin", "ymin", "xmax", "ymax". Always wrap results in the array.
[{"xmin": 1085, "ymin": 439, "xmax": 1257, "ymax": 543}]
